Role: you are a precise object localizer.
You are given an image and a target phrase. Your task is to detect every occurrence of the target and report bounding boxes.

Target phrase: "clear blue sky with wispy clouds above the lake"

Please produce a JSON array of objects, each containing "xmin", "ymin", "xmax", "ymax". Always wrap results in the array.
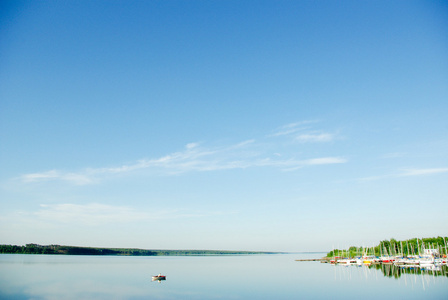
[{"xmin": 0, "ymin": 1, "xmax": 448, "ymax": 251}]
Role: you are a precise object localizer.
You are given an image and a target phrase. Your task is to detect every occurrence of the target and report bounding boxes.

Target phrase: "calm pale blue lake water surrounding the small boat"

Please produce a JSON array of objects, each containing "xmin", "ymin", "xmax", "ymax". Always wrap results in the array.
[{"xmin": 0, "ymin": 254, "xmax": 448, "ymax": 300}]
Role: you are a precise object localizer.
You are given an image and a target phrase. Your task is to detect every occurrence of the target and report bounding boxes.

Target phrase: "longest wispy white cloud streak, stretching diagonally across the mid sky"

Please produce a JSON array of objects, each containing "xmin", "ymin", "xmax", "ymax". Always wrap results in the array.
[{"xmin": 20, "ymin": 121, "xmax": 347, "ymax": 185}]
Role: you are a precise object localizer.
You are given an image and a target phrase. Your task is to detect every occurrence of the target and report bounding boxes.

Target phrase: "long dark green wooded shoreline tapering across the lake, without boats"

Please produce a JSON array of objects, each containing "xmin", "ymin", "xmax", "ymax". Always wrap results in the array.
[{"xmin": 0, "ymin": 244, "xmax": 282, "ymax": 256}]
